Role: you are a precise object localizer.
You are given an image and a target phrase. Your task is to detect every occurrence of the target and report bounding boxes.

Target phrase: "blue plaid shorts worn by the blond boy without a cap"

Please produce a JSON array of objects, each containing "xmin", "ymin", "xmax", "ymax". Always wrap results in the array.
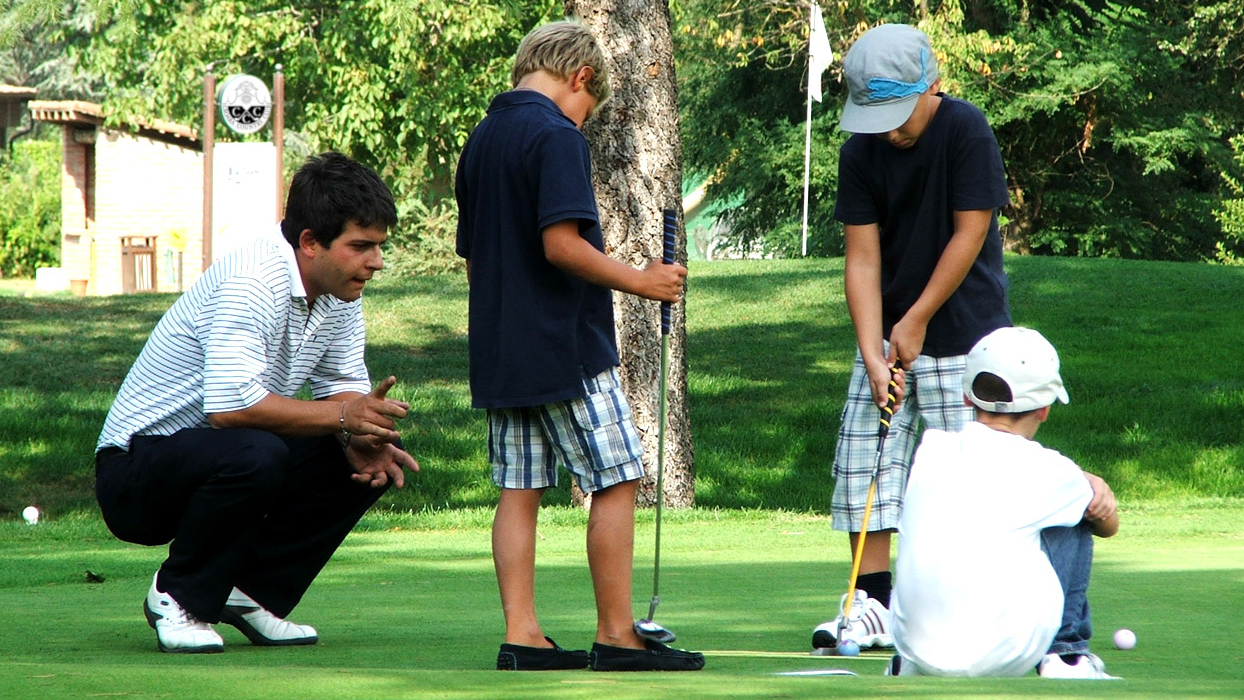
[{"xmin": 488, "ymin": 368, "xmax": 643, "ymax": 494}]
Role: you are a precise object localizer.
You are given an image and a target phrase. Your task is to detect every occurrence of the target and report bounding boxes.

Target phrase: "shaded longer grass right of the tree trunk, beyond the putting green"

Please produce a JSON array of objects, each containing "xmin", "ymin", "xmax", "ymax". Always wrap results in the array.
[{"xmin": 687, "ymin": 257, "xmax": 1244, "ymax": 512}]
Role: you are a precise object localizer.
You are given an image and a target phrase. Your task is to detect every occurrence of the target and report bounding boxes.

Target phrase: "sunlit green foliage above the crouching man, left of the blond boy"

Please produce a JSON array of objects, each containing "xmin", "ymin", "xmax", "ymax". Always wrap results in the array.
[{"xmin": 0, "ymin": 0, "xmax": 561, "ymax": 273}]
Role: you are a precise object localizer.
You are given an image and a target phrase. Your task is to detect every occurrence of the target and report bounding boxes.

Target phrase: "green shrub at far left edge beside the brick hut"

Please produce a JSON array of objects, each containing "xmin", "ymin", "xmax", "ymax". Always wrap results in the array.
[{"xmin": 0, "ymin": 140, "xmax": 61, "ymax": 277}]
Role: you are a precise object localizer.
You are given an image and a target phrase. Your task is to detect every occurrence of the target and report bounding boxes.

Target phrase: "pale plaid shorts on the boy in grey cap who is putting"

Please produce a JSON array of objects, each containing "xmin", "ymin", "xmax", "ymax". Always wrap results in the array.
[{"xmin": 830, "ymin": 352, "xmax": 974, "ymax": 532}]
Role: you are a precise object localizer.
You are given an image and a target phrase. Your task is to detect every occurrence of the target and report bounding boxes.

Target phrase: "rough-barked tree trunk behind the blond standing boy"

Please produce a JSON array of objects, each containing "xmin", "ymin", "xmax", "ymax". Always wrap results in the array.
[{"xmin": 566, "ymin": 0, "xmax": 695, "ymax": 507}]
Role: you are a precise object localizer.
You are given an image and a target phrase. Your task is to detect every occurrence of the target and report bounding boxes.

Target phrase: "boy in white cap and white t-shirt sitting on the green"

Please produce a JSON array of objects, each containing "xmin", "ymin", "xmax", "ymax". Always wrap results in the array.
[{"xmin": 887, "ymin": 328, "xmax": 1118, "ymax": 679}]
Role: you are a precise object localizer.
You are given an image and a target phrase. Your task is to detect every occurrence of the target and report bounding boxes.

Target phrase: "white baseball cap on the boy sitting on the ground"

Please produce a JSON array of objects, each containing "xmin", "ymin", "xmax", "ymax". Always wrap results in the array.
[{"xmin": 963, "ymin": 327, "xmax": 1071, "ymax": 413}]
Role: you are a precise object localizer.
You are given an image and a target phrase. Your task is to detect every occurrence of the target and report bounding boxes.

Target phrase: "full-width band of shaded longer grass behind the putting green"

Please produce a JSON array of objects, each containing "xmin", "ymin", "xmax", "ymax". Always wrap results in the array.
[{"xmin": 0, "ymin": 257, "xmax": 1244, "ymax": 517}]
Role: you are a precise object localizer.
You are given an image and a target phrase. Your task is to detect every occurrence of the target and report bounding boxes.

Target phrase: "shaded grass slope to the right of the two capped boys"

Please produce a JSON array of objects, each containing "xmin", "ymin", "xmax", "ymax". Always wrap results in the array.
[{"xmin": 1008, "ymin": 257, "xmax": 1244, "ymax": 496}]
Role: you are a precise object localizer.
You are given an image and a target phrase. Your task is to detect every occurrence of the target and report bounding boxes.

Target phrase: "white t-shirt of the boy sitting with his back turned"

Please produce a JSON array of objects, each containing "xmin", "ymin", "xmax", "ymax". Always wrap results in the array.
[{"xmin": 891, "ymin": 423, "xmax": 1092, "ymax": 676}]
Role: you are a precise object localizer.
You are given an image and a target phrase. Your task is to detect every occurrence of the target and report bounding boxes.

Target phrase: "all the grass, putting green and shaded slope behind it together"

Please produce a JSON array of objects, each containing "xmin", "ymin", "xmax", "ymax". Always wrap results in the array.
[{"xmin": 0, "ymin": 257, "xmax": 1244, "ymax": 700}]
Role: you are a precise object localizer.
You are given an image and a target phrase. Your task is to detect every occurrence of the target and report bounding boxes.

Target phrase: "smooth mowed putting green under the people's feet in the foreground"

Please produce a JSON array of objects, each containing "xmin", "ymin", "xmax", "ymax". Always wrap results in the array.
[{"xmin": 0, "ymin": 500, "xmax": 1244, "ymax": 700}]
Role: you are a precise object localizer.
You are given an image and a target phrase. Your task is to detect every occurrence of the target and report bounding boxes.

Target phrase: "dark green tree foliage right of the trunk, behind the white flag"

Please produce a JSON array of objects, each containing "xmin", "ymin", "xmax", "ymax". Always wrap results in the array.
[{"xmin": 678, "ymin": 0, "xmax": 1244, "ymax": 260}]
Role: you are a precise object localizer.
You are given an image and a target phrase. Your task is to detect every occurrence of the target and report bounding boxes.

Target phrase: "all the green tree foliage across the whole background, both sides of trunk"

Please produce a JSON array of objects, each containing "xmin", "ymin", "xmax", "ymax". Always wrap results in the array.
[{"xmin": 0, "ymin": 0, "xmax": 1244, "ymax": 269}]
